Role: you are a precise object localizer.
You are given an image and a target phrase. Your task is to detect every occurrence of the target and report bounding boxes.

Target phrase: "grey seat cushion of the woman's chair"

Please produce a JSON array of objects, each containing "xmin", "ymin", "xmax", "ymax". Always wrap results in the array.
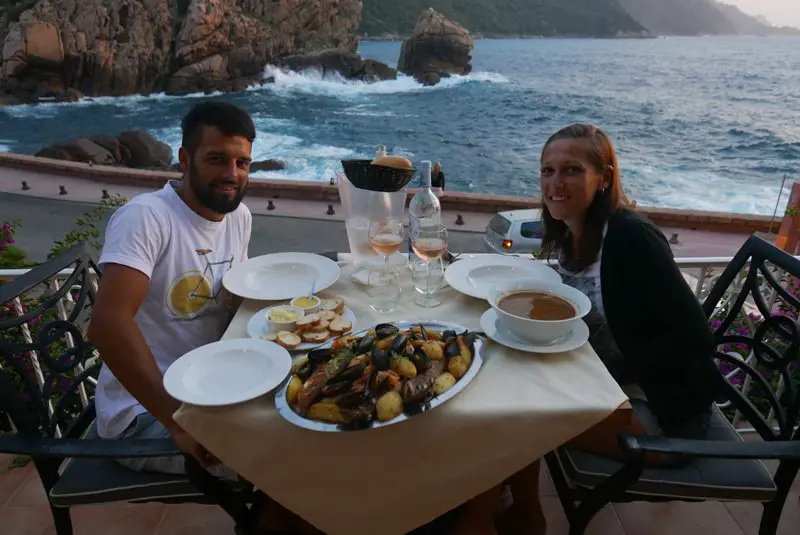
[{"xmin": 556, "ymin": 409, "xmax": 776, "ymax": 502}]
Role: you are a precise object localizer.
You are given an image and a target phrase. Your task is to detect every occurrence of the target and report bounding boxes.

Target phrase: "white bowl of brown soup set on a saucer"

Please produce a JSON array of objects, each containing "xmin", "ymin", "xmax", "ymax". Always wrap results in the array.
[{"xmin": 488, "ymin": 279, "xmax": 592, "ymax": 345}]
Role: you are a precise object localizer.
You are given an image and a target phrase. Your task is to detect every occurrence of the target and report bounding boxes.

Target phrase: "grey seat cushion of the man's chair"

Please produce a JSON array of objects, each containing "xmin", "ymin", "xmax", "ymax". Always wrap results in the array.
[{"xmin": 50, "ymin": 424, "xmax": 203, "ymax": 507}]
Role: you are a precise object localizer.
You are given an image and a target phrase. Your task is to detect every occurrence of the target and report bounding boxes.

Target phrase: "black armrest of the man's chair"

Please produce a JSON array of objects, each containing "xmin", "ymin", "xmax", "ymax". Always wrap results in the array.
[{"xmin": 0, "ymin": 435, "xmax": 183, "ymax": 458}]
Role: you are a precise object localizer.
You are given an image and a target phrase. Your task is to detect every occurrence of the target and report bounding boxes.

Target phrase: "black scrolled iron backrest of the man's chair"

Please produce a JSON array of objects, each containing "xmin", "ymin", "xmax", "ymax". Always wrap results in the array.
[{"xmin": 0, "ymin": 243, "xmax": 101, "ymax": 438}]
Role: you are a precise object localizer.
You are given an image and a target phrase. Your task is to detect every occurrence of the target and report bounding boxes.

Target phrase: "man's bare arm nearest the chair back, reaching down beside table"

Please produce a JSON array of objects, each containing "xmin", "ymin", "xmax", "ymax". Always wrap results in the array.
[{"xmin": 88, "ymin": 264, "xmax": 180, "ymax": 433}]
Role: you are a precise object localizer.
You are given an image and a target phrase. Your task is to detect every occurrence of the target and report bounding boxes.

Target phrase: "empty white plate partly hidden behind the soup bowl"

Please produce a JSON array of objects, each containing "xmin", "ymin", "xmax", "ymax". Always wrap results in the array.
[{"xmin": 444, "ymin": 255, "xmax": 561, "ymax": 299}]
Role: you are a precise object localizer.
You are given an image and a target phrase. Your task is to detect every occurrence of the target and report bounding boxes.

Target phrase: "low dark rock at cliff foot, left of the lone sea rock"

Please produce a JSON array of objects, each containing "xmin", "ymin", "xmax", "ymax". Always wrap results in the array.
[{"xmin": 278, "ymin": 48, "xmax": 397, "ymax": 82}]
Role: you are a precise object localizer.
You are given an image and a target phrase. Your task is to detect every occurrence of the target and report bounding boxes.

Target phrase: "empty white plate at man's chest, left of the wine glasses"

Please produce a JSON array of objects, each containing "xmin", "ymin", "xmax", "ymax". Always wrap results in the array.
[{"xmin": 222, "ymin": 253, "xmax": 342, "ymax": 301}]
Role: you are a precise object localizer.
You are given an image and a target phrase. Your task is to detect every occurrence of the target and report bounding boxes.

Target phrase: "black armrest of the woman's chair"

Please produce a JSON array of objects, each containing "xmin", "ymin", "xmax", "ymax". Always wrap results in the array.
[{"xmin": 619, "ymin": 435, "xmax": 800, "ymax": 461}]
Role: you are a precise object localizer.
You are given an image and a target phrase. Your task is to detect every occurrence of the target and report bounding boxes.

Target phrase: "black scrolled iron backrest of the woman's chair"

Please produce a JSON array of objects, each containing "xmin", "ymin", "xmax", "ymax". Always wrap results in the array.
[{"xmin": 703, "ymin": 236, "xmax": 800, "ymax": 440}]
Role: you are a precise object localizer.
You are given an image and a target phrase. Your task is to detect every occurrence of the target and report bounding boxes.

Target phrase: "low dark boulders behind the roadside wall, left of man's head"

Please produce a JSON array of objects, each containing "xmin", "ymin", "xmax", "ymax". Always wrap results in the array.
[{"xmin": 35, "ymin": 130, "xmax": 172, "ymax": 169}]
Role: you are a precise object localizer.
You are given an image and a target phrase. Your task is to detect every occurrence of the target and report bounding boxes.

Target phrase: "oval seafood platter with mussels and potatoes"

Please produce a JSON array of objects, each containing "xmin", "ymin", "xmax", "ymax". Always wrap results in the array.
[{"xmin": 275, "ymin": 321, "xmax": 483, "ymax": 432}]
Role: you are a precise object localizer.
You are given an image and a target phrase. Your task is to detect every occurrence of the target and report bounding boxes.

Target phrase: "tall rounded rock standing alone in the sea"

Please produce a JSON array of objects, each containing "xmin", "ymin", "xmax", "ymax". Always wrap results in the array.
[{"xmin": 397, "ymin": 9, "xmax": 475, "ymax": 85}]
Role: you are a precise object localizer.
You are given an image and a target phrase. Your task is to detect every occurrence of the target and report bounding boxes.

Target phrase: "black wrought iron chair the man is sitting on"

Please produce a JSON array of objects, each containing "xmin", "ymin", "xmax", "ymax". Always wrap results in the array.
[{"xmin": 0, "ymin": 244, "xmax": 260, "ymax": 535}]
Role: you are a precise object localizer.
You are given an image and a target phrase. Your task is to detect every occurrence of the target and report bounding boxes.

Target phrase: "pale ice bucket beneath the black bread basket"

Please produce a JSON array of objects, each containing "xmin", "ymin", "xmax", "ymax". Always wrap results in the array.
[{"xmin": 338, "ymin": 163, "xmax": 407, "ymax": 264}]
